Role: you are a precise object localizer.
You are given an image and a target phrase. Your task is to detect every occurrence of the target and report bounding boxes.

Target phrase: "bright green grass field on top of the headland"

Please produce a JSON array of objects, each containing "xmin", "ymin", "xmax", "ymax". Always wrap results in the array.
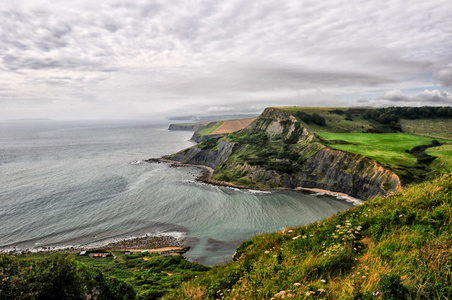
[{"xmin": 318, "ymin": 132, "xmax": 440, "ymax": 166}]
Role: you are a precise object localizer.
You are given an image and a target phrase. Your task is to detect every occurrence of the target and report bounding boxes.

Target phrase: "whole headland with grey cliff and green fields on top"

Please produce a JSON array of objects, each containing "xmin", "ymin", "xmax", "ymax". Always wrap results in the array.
[{"xmin": 169, "ymin": 107, "xmax": 452, "ymax": 200}]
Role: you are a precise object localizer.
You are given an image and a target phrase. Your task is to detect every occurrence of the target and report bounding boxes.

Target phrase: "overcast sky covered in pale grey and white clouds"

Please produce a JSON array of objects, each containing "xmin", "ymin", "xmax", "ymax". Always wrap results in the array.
[{"xmin": 0, "ymin": 0, "xmax": 452, "ymax": 119}]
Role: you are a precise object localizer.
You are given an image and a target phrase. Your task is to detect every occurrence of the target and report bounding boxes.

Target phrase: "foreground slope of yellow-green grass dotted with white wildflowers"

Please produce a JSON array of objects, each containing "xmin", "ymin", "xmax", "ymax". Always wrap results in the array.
[{"xmin": 164, "ymin": 175, "xmax": 452, "ymax": 300}]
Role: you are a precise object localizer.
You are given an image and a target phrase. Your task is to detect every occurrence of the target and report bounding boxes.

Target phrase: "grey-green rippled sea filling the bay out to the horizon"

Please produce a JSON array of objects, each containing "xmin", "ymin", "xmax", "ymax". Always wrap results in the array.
[{"xmin": 0, "ymin": 121, "xmax": 354, "ymax": 265}]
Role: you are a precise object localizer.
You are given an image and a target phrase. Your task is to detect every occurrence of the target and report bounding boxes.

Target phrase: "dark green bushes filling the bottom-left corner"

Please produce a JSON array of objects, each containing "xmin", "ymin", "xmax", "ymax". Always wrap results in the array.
[{"xmin": 0, "ymin": 254, "xmax": 136, "ymax": 299}]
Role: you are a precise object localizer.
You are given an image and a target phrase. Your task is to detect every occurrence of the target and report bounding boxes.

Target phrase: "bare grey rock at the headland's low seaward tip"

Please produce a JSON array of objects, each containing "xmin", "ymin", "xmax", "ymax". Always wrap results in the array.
[{"xmin": 171, "ymin": 139, "xmax": 234, "ymax": 169}]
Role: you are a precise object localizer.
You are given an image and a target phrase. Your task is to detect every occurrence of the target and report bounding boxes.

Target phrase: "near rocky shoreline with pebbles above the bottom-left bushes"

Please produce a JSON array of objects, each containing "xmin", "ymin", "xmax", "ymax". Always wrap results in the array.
[{"xmin": 0, "ymin": 235, "xmax": 190, "ymax": 255}]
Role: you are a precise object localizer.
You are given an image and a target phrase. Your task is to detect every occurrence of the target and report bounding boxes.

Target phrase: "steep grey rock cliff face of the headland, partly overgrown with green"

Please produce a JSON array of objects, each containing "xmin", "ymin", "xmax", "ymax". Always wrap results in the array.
[{"xmin": 172, "ymin": 109, "xmax": 401, "ymax": 200}]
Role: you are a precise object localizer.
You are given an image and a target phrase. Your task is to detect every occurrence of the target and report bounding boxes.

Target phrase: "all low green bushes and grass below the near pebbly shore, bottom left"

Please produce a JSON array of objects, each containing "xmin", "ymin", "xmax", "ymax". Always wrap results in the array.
[{"xmin": 0, "ymin": 251, "xmax": 210, "ymax": 299}]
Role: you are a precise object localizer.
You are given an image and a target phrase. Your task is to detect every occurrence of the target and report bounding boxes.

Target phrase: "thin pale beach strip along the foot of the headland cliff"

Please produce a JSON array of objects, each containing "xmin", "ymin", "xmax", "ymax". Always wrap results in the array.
[{"xmin": 145, "ymin": 157, "xmax": 365, "ymax": 205}]
